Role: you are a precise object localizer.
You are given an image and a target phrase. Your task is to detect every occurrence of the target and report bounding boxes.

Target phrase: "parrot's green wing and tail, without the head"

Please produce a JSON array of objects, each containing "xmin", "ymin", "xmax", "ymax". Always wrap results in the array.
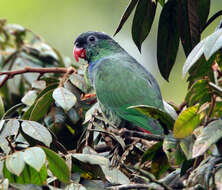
[{"xmin": 93, "ymin": 57, "xmax": 163, "ymax": 134}]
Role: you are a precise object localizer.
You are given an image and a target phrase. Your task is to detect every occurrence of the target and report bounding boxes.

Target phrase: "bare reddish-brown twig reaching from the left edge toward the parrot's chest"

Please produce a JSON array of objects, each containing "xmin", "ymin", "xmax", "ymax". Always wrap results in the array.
[{"xmin": 0, "ymin": 67, "xmax": 76, "ymax": 88}]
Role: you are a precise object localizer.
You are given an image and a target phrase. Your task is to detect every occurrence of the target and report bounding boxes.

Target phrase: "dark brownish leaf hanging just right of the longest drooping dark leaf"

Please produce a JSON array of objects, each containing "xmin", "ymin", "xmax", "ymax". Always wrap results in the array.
[{"xmin": 177, "ymin": 0, "xmax": 200, "ymax": 56}]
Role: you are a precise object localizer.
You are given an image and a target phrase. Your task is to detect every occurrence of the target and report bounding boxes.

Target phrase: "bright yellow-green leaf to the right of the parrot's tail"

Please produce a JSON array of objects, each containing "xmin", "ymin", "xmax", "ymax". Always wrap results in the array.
[{"xmin": 173, "ymin": 105, "xmax": 202, "ymax": 138}]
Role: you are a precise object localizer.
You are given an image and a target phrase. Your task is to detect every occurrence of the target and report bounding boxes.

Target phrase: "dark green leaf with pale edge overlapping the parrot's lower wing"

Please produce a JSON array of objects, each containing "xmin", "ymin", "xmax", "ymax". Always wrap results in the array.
[{"xmin": 129, "ymin": 105, "xmax": 174, "ymax": 129}]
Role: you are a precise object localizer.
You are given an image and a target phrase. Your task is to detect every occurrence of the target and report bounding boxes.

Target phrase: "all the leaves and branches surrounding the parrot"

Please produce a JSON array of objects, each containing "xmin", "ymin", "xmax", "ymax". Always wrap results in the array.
[{"xmin": 0, "ymin": 0, "xmax": 222, "ymax": 190}]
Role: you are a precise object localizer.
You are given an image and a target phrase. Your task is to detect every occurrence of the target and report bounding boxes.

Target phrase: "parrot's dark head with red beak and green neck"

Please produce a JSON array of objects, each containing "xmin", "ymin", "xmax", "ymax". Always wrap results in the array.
[{"xmin": 73, "ymin": 32, "xmax": 119, "ymax": 62}]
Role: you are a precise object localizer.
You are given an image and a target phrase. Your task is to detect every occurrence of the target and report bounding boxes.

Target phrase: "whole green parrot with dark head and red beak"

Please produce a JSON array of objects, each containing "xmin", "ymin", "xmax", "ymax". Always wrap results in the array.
[{"xmin": 73, "ymin": 32, "xmax": 175, "ymax": 135}]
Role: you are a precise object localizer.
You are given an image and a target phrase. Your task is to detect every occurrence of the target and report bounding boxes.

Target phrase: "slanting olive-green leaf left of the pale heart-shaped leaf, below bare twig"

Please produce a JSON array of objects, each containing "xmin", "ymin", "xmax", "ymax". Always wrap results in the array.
[{"xmin": 29, "ymin": 89, "xmax": 53, "ymax": 121}]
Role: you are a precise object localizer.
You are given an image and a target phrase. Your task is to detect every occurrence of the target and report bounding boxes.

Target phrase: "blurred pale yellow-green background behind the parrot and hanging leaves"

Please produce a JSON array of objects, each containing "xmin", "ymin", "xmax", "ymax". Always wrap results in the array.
[{"xmin": 0, "ymin": 0, "xmax": 222, "ymax": 104}]
